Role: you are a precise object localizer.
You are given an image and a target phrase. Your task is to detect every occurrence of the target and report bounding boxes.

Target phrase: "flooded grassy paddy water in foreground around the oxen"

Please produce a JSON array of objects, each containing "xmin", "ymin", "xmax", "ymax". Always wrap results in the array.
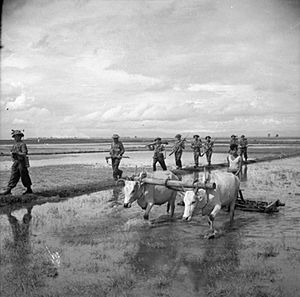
[{"xmin": 0, "ymin": 158, "xmax": 300, "ymax": 297}]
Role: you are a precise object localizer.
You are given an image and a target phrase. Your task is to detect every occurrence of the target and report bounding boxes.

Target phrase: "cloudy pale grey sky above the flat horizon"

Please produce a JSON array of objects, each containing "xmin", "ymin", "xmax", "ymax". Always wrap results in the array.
[{"xmin": 0, "ymin": 0, "xmax": 300, "ymax": 139}]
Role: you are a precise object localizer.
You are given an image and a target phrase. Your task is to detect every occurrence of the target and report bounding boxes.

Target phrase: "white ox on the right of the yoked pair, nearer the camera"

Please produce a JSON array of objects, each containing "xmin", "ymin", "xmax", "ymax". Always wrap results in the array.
[{"xmin": 182, "ymin": 172, "xmax": 240, "ymax": 234}]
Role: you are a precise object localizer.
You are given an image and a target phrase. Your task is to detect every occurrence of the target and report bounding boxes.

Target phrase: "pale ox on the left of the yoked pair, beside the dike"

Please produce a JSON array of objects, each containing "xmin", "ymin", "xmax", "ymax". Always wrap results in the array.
[{"xmin": 120, "ymin": 171, "xmax": 178, "ymax": 220}]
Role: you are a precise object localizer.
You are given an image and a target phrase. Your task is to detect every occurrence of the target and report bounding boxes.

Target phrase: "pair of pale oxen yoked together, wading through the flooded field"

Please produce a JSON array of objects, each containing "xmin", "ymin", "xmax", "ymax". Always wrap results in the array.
[{"xmin": 118, "ymin": 171, "xmax": 240, "ymax": 236}]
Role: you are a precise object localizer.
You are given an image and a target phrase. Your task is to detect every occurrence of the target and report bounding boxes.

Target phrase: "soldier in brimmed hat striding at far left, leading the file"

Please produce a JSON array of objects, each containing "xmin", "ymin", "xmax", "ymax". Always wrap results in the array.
[{"xmin": 1, "ymin": 130, "xmax": 33, "ymax": 195}]
